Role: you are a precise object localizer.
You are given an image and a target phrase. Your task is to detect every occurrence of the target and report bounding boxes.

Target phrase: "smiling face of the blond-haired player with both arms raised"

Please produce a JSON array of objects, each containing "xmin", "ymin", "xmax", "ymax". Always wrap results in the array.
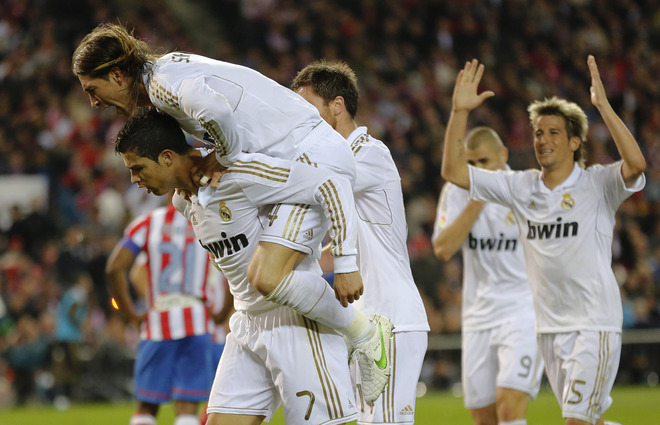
[{"xmin": 534, "ymin": 115, "xmax": 580, "ymax": 169}]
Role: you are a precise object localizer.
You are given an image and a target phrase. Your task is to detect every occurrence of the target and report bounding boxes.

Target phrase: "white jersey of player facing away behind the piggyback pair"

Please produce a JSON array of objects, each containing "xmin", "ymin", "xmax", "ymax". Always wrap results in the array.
[{"xmin": 348, "ymin": 127, "xmax": 429, "ymax": 332}]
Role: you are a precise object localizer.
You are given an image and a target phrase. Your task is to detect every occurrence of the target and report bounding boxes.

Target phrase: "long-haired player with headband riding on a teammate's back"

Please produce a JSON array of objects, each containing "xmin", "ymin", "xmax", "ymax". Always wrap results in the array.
[{"xmin": 72, "ymin": 24, "xmax": 363, "ymax": 312}]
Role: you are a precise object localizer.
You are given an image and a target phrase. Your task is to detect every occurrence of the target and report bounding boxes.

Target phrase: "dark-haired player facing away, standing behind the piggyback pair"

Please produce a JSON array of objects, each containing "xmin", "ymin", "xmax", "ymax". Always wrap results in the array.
[{"xmin": 291, "ymin": 61, "xmax": 429, "ymax": 424}]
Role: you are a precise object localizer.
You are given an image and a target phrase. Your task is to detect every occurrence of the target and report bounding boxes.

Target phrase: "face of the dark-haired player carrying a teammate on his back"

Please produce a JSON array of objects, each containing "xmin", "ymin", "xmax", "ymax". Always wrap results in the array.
[{"xmin": 121, "ymin": 152, "xmax": 177, "ymax": 196}]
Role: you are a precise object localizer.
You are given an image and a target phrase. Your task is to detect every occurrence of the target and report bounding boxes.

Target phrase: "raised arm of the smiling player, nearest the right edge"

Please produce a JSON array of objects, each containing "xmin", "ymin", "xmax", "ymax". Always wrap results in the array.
[{"xmin": 587, "ymin": 55, "xmax": 646, "ymax": 186}]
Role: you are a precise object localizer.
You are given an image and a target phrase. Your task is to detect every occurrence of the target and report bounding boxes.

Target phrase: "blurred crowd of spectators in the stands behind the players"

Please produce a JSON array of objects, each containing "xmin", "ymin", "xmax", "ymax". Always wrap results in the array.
[{"xmin": 0, "ymin": 0, "xmax": 660, "ymax": 405}]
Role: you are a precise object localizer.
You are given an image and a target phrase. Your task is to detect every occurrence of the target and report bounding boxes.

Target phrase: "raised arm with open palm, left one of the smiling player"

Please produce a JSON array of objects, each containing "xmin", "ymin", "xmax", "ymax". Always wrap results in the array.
[{"xmin": 442, "ymin": 59, "xmax": 495, "ymax": 189}]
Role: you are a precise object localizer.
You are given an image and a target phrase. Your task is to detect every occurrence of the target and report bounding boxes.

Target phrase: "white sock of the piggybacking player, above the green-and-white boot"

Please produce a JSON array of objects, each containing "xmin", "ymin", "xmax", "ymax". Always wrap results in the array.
[{"xmin": 266, "ymin": 270, "xmax": 375, "ymax": 346}]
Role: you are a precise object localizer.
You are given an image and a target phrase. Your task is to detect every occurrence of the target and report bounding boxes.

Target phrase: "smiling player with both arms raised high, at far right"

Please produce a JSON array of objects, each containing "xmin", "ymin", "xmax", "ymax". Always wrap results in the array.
[{"xmin": 442, "ymin": 56, "xmax": 646, "ymax": 425}]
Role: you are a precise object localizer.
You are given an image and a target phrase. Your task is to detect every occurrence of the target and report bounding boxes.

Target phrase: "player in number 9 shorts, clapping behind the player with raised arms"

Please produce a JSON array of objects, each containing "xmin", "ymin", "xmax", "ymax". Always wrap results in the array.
[{"xmin": 433, "ymin": 127, "xmax": 543, "ymax": 425}]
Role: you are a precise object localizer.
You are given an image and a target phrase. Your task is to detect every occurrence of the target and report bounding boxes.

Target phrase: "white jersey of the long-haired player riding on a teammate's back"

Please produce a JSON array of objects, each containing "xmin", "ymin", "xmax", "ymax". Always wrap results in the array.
[{"xmin": 145, "ymin": 53, "xmax": 329, "ymax": 166}]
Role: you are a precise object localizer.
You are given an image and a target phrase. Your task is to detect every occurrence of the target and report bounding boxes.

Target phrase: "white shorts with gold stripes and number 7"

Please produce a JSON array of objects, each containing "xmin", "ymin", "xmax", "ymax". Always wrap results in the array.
[{"xmin": 207, "ymin": 307, "xmax": 357, "ymax": 425}]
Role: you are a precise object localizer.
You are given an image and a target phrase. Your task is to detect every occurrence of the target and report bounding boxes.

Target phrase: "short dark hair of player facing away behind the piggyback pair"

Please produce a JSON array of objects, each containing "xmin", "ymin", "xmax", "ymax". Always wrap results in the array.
[{"xmin": 291, "ymin": 60, "xmax": 359, "ymax": 118}]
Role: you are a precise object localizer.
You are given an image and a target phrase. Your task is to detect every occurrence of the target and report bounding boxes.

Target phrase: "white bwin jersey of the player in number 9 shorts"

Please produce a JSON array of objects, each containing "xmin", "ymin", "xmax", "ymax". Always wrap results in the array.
[{"xmin": 433, "ymin": 183, "xmax": 534, "ymax": 331}]
